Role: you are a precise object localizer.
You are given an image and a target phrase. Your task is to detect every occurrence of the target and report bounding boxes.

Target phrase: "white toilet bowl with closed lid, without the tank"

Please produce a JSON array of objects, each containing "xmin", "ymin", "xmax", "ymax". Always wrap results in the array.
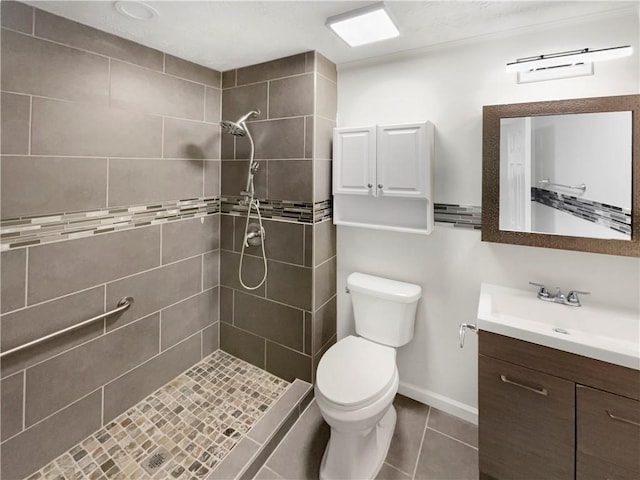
[{"xmin": 315, "ymin": 336, "xmax": 399, "ymax": 480}]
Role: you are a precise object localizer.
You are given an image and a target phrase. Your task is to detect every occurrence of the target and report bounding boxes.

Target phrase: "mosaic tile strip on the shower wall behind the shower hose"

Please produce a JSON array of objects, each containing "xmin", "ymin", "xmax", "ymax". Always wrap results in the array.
[{"xmin": 220, "ymin": 196, "xmax": 333, "ymax": 224}]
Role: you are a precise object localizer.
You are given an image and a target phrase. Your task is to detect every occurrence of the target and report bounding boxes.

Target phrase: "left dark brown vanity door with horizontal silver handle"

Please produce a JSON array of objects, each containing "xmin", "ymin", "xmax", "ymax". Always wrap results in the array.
[{"xmin": 478, "ymin": 355, "xmax": 575, "ymax": 480}]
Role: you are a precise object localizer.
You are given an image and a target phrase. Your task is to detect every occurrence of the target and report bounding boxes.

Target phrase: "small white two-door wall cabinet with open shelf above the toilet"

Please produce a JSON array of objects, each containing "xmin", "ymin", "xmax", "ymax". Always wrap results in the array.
[{"xmin": 333, "ymin": 122, "xmax": 434, "ymax": 234}]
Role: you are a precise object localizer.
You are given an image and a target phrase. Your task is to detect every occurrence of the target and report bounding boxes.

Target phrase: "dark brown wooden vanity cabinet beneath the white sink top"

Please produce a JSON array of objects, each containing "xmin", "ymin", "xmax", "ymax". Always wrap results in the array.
[{"xmin": 478, "ymin": 331, "xmax": 640, "ymax": 480}]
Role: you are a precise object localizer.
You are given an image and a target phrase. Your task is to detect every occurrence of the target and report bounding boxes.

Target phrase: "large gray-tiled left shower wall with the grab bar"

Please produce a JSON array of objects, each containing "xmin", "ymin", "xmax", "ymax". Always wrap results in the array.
[{"xmin": 0, "ymin": 1, "xmax": 222, "ymax": 479}]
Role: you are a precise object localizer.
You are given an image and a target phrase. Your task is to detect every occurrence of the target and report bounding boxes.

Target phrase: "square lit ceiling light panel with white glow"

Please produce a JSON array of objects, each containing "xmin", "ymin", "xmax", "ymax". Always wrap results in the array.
[{"xmin": 325, "ymin": 2, "xmax": 400, "ymax": 47}]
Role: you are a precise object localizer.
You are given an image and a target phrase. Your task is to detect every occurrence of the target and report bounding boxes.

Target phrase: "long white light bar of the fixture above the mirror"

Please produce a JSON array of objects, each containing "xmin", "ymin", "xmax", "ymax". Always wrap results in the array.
[{"xmin": 507, "ymin": 45, "xmax": 633, "ymax": 72}]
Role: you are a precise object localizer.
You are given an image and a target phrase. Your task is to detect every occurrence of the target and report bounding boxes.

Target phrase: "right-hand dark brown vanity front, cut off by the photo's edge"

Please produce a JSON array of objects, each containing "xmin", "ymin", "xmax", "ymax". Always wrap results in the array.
[{"xmin": 576, "ymin": 385, "xmax": 640, "ymax": 472}]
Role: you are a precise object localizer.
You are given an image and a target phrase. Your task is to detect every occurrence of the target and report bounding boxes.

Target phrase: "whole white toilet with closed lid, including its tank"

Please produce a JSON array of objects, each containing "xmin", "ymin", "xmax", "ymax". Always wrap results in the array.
[{"xmin": 315, "ymin": 272, "xmax": 422, "ymax": 480}]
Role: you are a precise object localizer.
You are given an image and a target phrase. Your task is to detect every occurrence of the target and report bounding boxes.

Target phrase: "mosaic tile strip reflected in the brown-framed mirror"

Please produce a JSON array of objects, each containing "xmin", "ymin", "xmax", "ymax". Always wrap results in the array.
[{"xmin": 531, "ymin": 187, "xmax": 631, "ymax": 235}]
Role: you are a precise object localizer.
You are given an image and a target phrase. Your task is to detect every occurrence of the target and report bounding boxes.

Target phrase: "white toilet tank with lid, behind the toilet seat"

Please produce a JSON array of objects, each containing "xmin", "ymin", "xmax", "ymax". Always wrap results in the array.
[{"xmin": 347, "ymin": 272, "xmax": 422, "ymax": 347}]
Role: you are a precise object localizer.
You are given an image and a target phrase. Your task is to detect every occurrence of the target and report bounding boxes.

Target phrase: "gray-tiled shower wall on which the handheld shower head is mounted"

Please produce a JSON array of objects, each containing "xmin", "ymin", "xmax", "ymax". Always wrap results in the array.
[{"xmin": 220, "ymin": 52, "xmax": 337, "ymax": 381}]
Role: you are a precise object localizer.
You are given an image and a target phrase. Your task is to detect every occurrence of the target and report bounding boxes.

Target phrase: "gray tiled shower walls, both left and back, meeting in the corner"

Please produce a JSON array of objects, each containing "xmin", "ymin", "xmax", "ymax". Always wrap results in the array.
[{"xmin": 0, "ymin": 1, "xmax": 336, "ymax": 478}]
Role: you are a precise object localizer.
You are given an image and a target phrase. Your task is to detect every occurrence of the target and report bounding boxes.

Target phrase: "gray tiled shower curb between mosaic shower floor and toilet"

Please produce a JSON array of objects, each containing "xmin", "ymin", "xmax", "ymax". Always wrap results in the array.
[{"xmin": 206, "ymin": 379, "xmax": 313, "ymax": 480}]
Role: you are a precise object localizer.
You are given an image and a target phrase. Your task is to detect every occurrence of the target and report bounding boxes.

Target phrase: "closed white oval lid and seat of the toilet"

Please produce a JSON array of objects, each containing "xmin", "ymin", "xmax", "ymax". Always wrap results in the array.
[{"xmin": 316, "ymin": 336, "xmax": 396, "ymax": 409}]
